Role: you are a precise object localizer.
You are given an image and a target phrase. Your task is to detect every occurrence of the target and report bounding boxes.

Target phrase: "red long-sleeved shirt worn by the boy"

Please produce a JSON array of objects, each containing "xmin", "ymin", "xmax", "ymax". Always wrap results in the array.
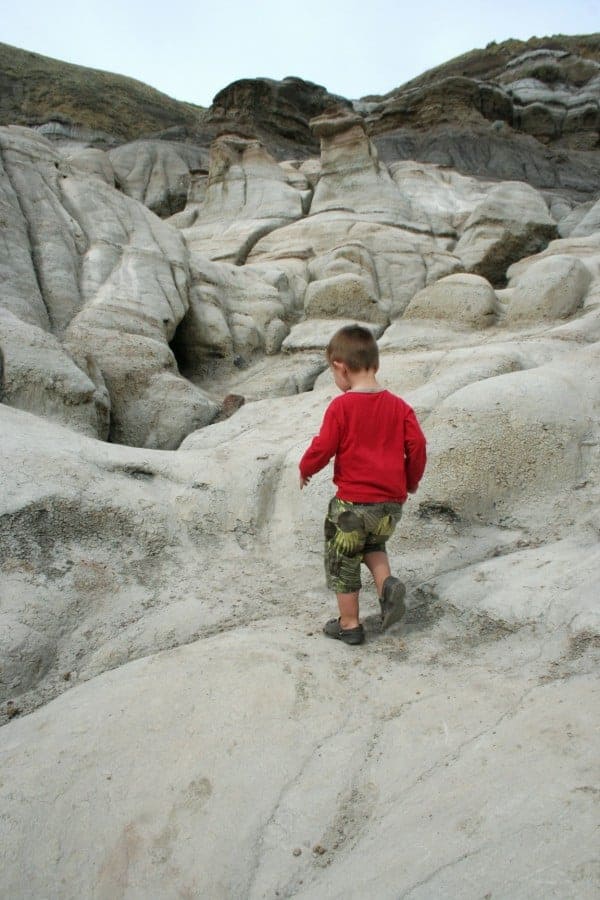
[{"xmin": 300, "ymin": 390, "xmax": 426, "ymax": 503}]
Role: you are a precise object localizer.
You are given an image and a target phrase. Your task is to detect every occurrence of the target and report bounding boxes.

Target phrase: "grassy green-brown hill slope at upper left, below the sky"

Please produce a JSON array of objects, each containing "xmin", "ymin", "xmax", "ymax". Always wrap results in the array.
[{"xmin": 0, "ymin": 44, "xmax": 202, "ymax": 141}]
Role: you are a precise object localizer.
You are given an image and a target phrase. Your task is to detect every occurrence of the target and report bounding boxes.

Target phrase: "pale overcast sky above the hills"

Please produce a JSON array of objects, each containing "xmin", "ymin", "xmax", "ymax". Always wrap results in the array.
[{"xmin": 0, "ymin": 0, "xmax": 600, "ymax": 106}]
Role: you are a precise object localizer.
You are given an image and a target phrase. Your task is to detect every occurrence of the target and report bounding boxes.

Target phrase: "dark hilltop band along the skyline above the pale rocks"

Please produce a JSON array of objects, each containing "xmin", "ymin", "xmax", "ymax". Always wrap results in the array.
[{"xmin": 0, "ymin": 34, "xmax": 600, "ymax": 198}]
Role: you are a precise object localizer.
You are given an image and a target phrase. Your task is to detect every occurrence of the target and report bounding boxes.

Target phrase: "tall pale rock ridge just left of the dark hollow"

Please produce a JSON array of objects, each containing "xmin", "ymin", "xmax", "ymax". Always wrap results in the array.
[{"xmin": 62, "ymin": 171, "xmax": 217, "ymax": 449}]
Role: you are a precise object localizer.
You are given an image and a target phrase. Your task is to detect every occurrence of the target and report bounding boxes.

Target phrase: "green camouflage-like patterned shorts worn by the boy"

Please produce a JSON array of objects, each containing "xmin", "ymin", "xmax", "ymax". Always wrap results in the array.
[{"xmin": 325, "ymin": 497, "xmax": 402, "ymax": 594}]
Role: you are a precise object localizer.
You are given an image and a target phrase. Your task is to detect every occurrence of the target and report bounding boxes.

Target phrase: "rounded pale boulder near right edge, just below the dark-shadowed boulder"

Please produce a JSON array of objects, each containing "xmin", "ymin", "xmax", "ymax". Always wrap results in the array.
[{"xmin": 507, "ymin": 254, "xmax": 592, "ymax": 322}]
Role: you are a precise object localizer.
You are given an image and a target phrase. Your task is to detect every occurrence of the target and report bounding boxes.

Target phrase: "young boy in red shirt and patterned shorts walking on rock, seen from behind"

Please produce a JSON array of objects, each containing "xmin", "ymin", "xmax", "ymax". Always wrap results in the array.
[{"xmin": 300, "ymin": 325, "xmax": 426, "ymax": 644}]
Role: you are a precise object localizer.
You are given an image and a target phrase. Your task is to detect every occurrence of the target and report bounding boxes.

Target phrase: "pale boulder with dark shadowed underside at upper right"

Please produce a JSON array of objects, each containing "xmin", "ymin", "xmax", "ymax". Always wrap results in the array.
[{"xmin": 453, "ymin": 182, "xmax": 557, "ymax": 284}]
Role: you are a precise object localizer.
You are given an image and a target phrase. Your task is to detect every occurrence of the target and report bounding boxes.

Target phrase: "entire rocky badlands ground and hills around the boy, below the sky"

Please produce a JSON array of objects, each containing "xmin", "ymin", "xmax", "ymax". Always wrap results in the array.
[{"xmin": 0, "ymin": 35, "xmax": 600, "ymax": 900}]
